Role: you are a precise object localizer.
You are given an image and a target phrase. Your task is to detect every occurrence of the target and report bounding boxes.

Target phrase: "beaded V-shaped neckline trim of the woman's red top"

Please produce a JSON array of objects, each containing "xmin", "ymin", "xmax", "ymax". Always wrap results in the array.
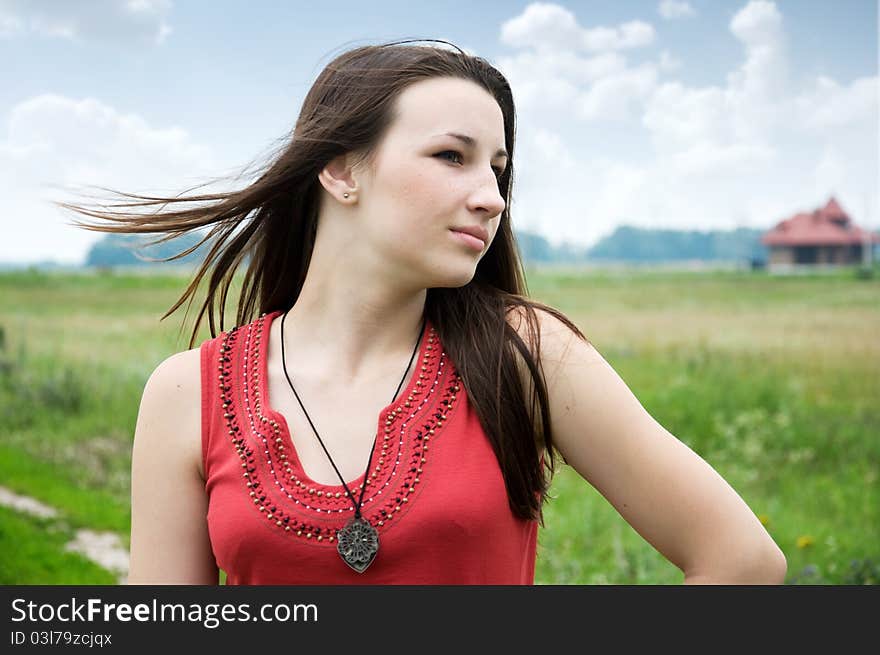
[{"xmin": 217, "ymin": 311, "xmax": 461, "ymax": 543}]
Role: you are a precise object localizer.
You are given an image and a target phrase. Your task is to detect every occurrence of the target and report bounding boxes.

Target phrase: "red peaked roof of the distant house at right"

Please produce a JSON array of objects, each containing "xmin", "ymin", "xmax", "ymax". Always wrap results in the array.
[{"xmin": 761, "ymin": 198, "xmax": 880, "ymax": 246}]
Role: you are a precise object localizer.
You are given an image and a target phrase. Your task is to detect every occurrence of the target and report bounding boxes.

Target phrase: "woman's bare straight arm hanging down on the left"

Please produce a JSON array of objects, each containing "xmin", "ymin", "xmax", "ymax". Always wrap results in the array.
[{"xmin": 128, "ymin": 348, "xmax": 219, "ymax": 585}]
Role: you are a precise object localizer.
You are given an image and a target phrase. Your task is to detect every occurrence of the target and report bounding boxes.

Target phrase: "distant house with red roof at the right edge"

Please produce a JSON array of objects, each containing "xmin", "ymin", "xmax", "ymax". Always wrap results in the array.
[{"xmin": 761, "ymin": 196, "xmax": 880, "ymax": 269}]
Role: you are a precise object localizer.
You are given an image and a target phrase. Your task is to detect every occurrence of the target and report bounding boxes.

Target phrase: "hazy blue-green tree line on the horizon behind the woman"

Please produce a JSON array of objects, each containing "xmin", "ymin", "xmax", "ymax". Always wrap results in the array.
[{"xmin": 85, "ymin": 226, "xmax": 767, "ymax": 267}]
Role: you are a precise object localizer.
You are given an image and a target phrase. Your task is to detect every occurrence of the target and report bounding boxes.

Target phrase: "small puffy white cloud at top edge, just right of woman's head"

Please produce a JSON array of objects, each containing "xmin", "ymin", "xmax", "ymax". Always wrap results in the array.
[{"xmin": 501, "ymin": 2, "xmax": 656, "ymax": 51}]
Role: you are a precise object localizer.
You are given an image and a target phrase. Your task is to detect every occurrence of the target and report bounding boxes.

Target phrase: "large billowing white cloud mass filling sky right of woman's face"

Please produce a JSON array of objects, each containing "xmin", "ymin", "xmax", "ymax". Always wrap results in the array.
[{"xmin": 492, "ymin": 0, "xmax": 880, "ymax": 244}]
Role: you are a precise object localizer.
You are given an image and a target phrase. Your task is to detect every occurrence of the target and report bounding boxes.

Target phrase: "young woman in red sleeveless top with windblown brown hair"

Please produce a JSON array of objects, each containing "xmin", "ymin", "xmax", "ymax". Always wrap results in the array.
[{"xmin": 65, "ymin": 42, "xmax": 786, "ymax": 585}]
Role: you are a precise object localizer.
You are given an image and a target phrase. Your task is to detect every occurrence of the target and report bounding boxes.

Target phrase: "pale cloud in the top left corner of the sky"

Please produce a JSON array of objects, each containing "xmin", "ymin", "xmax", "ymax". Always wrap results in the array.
[{"xmin": 0, "ymin": 0, "xmax": 172, "ymax": 44}]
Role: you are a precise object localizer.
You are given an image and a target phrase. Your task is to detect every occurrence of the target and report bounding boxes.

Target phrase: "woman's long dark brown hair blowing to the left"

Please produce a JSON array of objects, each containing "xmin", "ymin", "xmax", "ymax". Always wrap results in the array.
[{"xmin": 57, "ymin": 39, "xmax": 586, "ymax": 525}]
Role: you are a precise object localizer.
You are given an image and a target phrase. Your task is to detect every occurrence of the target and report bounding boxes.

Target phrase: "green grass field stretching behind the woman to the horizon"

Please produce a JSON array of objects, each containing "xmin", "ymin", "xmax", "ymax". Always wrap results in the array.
[{"xmin": 0, "ymin": 269, "xmax": 880, "ymax": 584}]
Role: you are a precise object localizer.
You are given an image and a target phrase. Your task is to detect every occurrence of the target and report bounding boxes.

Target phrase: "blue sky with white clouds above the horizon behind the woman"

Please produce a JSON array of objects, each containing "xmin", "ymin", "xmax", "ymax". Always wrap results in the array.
[{"xmin": 0, "ymin": 0, "xmax": 880, "ymax": 263}]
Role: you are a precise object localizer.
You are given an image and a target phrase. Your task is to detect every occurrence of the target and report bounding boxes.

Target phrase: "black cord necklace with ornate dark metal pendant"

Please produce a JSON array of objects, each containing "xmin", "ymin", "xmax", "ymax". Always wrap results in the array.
[{"xmin": 281, "ymin": 310, "xmax": 427, "ymax": 573}]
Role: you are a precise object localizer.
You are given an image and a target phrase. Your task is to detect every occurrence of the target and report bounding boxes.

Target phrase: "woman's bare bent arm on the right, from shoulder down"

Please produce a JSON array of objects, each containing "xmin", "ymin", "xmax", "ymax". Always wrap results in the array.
[{"xmin": 519, "ymin": 310, "xmax": 787, "ymax": 584}]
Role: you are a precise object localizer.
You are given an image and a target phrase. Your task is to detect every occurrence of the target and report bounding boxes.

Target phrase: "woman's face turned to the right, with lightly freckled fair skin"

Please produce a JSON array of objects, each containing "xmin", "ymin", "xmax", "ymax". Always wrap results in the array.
[{"xmin": 348, "ymin": 78, "xmax": 507, "ymax": 288}]
